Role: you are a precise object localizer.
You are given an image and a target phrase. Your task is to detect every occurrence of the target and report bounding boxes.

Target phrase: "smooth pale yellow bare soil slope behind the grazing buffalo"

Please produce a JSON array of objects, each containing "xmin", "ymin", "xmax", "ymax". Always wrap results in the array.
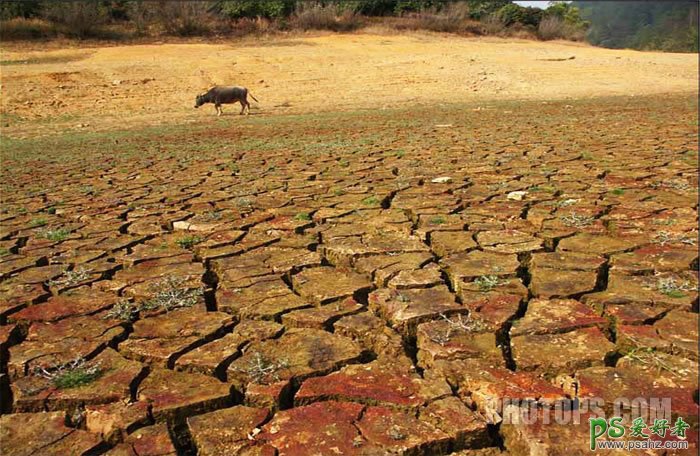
[{"xmin": 1, "ymin": 33, "xmax": 698, "ymax": 137}]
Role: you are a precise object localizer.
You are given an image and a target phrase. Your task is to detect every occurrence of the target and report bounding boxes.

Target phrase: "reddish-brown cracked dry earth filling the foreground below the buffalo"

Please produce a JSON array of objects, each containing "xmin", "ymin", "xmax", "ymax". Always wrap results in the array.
[{"xmin": 0, "ymin": 96, "xmax": 698, "ymax": 456}]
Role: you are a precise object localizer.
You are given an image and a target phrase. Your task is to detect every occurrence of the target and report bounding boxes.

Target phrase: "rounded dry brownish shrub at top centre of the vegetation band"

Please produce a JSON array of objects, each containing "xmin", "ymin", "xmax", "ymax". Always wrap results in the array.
[{"xmin": 292, "ymin": 2, "xmax": 362, "ymax": 32}]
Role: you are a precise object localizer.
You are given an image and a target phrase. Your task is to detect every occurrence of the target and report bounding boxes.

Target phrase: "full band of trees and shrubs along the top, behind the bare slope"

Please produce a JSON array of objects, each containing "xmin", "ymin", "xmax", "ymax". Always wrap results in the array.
[{"xmin": 0, "ymin": 0, "xmax": 698, "ymax": 52}]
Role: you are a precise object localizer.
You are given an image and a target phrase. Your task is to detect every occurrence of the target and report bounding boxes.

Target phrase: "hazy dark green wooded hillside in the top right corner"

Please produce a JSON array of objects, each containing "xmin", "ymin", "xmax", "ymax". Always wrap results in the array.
[{"xmin": 573, "ymin": 1, "xmax": 698, "ymax": 52}]
